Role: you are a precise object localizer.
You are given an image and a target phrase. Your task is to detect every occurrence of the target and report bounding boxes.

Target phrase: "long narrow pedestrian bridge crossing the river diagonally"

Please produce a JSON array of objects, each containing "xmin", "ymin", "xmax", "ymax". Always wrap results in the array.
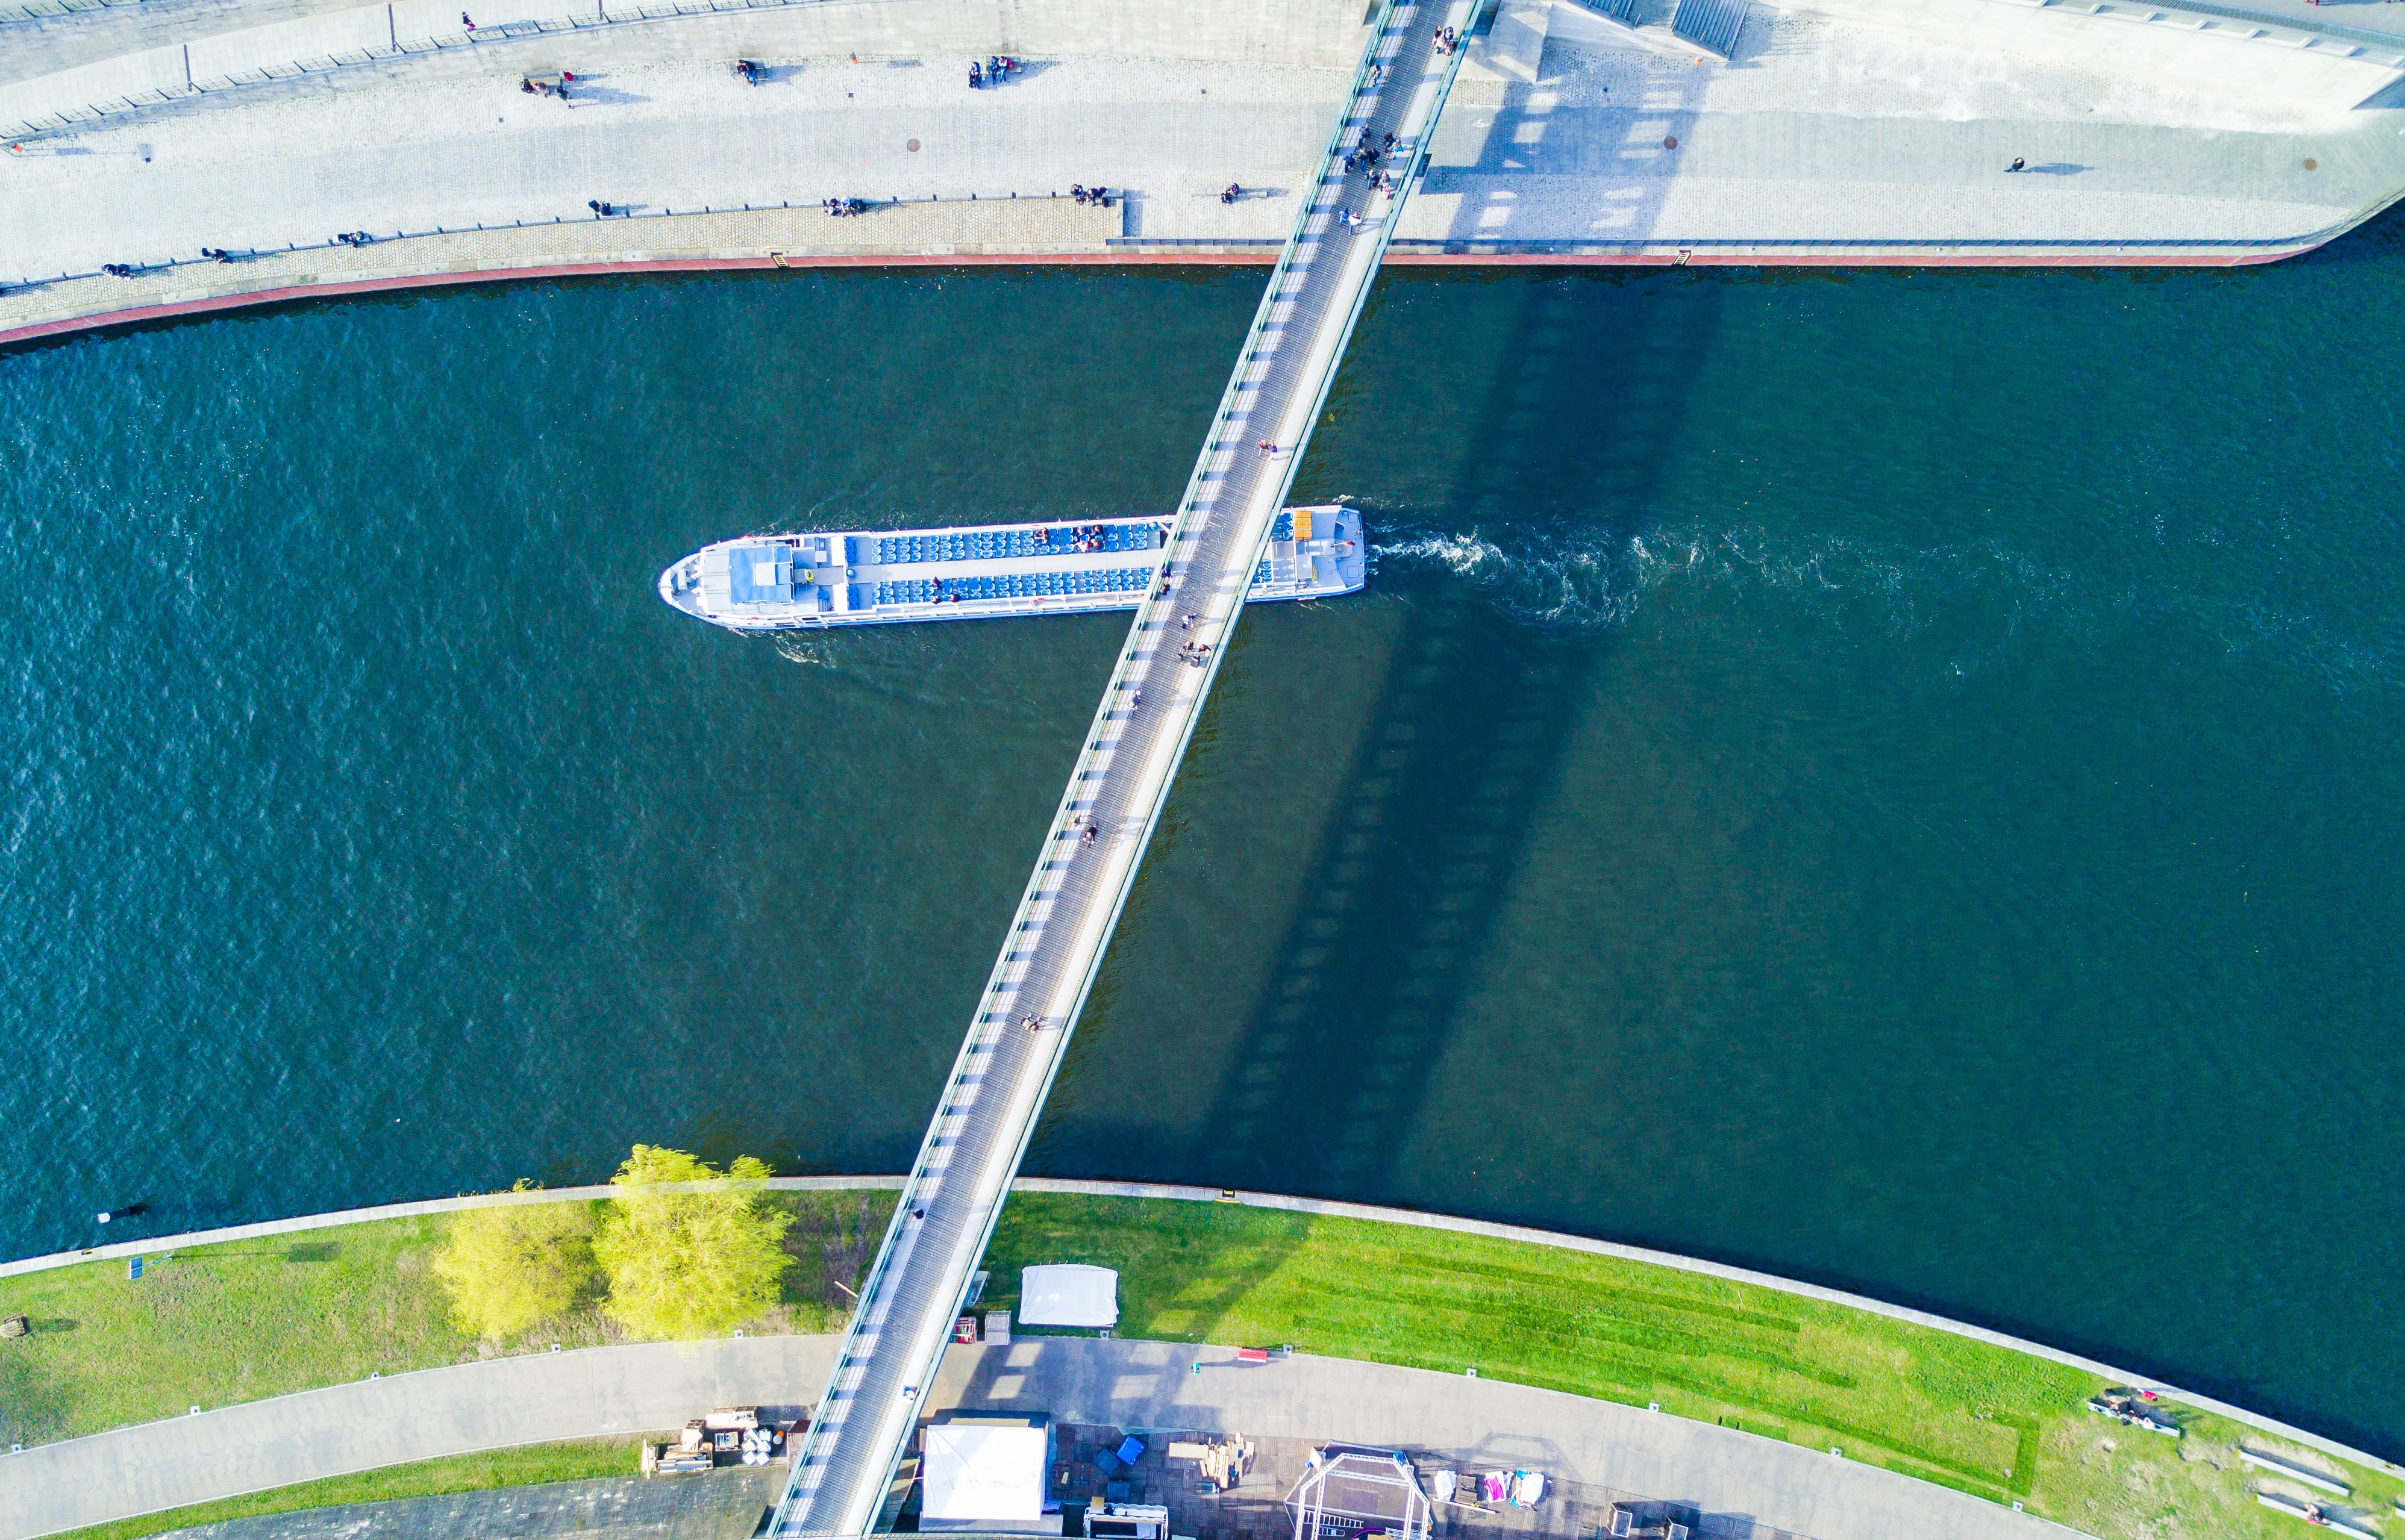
[{"xmin": 772, "ymin": 0, "xmax": 1477, "ymax": 1535}]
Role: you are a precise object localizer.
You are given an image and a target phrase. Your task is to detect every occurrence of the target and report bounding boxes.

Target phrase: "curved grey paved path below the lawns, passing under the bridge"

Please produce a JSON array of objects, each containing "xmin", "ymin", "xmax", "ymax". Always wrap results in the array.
[{"xmin": 0, "ymin": 1336, "xmax": 2068, "ymax": 1540}]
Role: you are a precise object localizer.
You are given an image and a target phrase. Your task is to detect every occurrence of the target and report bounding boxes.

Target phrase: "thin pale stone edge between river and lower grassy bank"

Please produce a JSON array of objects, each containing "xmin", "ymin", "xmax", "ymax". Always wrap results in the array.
[{"xmin": 0, "ymin": 1177, "xmax": 2405, "ymax": 1475}]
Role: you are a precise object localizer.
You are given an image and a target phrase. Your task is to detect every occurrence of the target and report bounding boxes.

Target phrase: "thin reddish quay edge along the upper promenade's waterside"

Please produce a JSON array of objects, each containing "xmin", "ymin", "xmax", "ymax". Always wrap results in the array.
[{"xmin": 0, "ymin": 238, "xmax": 2321, "ymax": 348}]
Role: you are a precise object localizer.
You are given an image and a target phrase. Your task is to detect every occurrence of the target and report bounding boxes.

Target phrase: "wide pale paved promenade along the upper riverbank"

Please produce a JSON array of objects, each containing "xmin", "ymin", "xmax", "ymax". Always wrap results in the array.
[{"xmin": 0, "ymin": 0, "xmax": 2405, "ymax": 341}]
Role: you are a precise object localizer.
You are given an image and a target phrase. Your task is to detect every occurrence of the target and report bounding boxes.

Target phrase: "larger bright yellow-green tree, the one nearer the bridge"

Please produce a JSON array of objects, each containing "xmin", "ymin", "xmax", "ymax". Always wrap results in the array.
[{"xmin": 594, "ymin": 1144, "xmax": 793, "ymax": 1338}]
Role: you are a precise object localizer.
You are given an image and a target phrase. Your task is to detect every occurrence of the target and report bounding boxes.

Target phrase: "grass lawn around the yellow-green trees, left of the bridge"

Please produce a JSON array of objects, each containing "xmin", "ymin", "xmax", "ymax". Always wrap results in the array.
[{"xmin": 0, "ymin": 1192, "xmax": 895, "ymax": 1444}]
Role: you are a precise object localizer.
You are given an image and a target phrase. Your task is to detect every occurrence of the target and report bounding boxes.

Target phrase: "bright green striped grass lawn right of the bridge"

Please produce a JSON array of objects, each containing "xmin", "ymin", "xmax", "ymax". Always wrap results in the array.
[{"xmin": 986, "ymin": 1194, "xmax": 2400, "ymax": 1540}]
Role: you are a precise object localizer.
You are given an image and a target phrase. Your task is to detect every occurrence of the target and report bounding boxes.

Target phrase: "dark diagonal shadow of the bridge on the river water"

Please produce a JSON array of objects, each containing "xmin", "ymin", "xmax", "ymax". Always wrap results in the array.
[{"xmin": 1056, "ymin": 258, "xmax": 1727, "ymax": 1341}]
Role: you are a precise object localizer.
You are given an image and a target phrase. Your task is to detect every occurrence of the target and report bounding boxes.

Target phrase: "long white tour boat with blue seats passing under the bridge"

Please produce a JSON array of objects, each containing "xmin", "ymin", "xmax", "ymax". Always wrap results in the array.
[{"xmin": 659, "ymin": 502, "xmax": 1368, "ymax": 632}]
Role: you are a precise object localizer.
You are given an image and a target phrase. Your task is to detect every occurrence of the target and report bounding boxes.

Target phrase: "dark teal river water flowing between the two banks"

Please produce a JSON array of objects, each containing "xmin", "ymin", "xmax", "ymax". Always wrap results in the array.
[{"xmin": 0, "ymin": 219, "xmax": 2405, "ymax": 1453}]
